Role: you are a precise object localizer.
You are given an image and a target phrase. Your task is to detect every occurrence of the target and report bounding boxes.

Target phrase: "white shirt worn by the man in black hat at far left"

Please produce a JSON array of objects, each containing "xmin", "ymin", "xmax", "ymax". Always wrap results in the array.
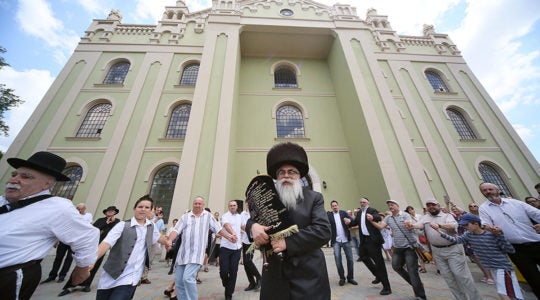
[{"xmin": 0, "ymin": 191, "xmax": 99, "ymax": 268}]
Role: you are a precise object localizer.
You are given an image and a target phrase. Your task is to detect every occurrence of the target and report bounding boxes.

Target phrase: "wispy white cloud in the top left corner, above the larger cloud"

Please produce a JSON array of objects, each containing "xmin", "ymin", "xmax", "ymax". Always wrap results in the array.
[{"xmin": 16, "ymin": 0, "xmax": 80, "ymax": 64}]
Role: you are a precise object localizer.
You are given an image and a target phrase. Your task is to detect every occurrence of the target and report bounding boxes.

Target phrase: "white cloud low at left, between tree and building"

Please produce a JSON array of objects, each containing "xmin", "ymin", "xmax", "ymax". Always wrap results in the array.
[{"xmin": 0, "ymin": 67, "xmax": 54, "ymax": 152}]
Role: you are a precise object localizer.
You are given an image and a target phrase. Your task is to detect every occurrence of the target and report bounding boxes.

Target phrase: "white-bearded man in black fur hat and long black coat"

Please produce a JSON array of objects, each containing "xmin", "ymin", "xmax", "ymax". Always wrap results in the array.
[{"xmin": 246, "ymin": 143, "xmax": 332, "ymax": 300}]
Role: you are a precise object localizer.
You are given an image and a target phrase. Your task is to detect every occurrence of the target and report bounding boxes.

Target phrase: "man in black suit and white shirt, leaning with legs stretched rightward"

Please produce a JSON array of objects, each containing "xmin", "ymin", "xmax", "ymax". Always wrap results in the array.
[{"xmin": 344, "ymin": 198, "xmax": 392, "ymax": 295}]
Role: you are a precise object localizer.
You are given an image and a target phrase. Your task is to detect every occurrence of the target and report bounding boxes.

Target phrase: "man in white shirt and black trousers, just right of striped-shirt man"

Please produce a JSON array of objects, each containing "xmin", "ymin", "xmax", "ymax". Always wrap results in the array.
[{"xmin": 219, "ymin": 200, "xmax": 242, "ymax": 300}]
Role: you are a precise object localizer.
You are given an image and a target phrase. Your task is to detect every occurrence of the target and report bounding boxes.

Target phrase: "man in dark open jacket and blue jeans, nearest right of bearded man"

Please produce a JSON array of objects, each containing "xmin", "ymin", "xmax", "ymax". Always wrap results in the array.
[{"xmin": 328, "ymin": 200, "xmax": 358, "ymax": 286}]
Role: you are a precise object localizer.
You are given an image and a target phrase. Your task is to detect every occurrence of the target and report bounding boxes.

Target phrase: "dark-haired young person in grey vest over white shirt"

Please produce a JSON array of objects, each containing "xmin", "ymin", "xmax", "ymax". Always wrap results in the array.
[{"xmin": 96, "ymin": 196, "xmax": 167, "ymax": 300}]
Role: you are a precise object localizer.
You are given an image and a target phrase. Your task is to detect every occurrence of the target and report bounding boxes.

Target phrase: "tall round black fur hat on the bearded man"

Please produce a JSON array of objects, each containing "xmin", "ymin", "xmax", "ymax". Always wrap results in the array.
[{"xmin": 266, "ymin": 142, "xmax": 309, "ymax": 179}]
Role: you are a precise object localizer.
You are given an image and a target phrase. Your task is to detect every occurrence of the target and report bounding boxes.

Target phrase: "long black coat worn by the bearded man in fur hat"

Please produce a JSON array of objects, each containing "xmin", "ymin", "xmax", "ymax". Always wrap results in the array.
[{"xmin": 246, "ymin": 188, "xmax": 332, "ymax": 300}]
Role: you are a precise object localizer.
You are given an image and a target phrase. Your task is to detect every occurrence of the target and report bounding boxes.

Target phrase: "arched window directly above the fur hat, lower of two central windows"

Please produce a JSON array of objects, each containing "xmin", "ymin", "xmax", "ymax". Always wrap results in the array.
[{"xmin": 276, "ymin": 105, "xmax": 305, "ymax": 138}]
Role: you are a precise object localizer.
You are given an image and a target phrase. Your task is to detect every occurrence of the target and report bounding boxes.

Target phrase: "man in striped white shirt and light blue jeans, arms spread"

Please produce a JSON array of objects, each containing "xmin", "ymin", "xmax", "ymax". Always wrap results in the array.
[{"xmin": 167, "ymin": 196, "xmax": 237, "ymax": 300}]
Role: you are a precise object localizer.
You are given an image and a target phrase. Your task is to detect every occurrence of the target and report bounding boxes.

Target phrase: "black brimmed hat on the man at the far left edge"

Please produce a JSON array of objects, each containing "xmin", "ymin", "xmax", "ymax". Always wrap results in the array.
[{"xmin": 7, "ymin": 151, "xmax": 71, "ymax": 181}]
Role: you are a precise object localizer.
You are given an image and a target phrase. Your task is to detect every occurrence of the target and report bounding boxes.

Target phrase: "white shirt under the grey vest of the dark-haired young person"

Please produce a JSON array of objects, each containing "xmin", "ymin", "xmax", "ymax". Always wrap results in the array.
[{"xmin": 98, "ymin": 217, "xmax": 161, "ymax": 290}]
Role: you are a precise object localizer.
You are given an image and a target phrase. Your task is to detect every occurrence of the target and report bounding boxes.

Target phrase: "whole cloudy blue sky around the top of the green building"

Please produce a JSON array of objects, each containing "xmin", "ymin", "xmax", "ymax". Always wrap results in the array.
[{"xmin": 0, "ymin": 0, "xmax": 540, "ymax": 164}]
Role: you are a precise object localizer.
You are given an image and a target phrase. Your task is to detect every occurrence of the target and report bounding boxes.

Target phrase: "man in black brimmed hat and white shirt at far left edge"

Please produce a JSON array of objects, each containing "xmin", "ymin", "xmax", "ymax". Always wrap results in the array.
[{"xmin": 0, "ymin": 151, "xmax": 99, "ymax": 299}]
